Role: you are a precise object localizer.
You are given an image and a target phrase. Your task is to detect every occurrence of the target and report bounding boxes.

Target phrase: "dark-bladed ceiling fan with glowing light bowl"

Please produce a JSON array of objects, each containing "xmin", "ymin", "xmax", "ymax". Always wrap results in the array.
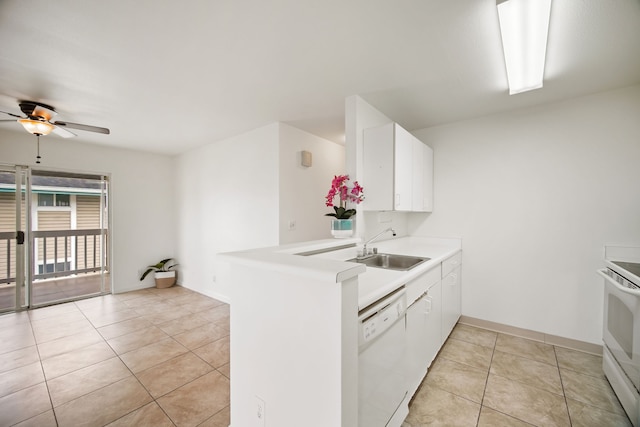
[{"xmin": 0, "ymin": 101, "xmax": 110, "ymax": 138}]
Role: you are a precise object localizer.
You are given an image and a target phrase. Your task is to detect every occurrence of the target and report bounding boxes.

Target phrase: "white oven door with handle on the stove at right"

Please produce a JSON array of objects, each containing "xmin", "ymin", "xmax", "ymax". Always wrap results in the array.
[{"xmin": 598, "ymin": 269, "xmax": 640, "ymax": 391}]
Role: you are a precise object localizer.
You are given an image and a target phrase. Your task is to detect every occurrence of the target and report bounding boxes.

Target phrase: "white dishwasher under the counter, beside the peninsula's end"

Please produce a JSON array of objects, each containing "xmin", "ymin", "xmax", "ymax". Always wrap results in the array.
[{"xmin": 358, "ymin": 286, "xmax": 408, "ymax": 427}]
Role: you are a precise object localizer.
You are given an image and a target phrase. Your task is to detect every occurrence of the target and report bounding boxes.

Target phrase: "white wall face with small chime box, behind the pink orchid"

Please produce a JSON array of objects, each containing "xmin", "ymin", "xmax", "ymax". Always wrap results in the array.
[{"xmin": 279, "ymin": 123, "xmax": 345, "ymax": 244}]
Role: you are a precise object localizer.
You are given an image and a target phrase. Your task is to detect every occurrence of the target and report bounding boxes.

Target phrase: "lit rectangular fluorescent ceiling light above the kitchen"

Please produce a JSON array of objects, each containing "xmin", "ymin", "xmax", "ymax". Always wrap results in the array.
[{"xmin": 498, "ymin": 0, "xmax": 551, "ymax": 95}]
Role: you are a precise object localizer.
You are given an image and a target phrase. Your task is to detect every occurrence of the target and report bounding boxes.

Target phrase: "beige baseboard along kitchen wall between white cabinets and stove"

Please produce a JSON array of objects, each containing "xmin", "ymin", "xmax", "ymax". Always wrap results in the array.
[{"xmin": 458, "ymin": 316, "xmax": 602, "ymax": 356}]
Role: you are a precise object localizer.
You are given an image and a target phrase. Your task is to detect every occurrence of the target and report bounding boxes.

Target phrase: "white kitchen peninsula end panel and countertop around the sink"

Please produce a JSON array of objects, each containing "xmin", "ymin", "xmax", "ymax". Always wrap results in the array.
[{"xmin": 221, "ymin": 237, "xmax": 461, "ymax": 427}]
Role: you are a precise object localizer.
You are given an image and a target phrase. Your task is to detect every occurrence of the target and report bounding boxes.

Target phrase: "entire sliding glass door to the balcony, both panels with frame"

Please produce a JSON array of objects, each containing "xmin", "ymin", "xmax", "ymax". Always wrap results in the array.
[{"xmin": 0, "ymin": 167, "xmax": 111, "ymax": 311}]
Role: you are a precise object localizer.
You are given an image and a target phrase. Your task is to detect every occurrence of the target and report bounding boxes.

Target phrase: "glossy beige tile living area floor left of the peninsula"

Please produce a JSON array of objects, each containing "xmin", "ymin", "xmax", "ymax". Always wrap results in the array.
[{"xmin": 0, "ymin": 286, "xmax": 230, "ymax": 427}]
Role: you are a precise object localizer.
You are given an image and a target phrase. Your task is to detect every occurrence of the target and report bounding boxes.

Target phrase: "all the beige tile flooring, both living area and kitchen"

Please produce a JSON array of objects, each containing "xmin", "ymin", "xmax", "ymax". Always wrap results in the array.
[{"xmin": 0, "ymin": 287, "xmax": 631, "ymax": 427}]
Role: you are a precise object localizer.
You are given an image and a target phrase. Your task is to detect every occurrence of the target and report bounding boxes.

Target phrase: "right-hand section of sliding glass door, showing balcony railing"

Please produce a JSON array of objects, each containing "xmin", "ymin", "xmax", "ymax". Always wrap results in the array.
[{"xmin": 30, "ymin": 170, "xmax": 111, "ymax": 306}]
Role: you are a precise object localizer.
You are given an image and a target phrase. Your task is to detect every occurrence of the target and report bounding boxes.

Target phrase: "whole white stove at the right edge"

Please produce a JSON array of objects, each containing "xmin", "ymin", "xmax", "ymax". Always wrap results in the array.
[{"xmin": 598, "ymin": 246, "xmax": 640, "ymax": 427}]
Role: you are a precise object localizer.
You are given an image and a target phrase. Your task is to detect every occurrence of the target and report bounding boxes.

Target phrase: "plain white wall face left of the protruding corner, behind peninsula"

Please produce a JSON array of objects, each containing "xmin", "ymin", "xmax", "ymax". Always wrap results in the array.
[{"xmin": 176, "ymin": 123, "xmax": 279, "ymax": 301}]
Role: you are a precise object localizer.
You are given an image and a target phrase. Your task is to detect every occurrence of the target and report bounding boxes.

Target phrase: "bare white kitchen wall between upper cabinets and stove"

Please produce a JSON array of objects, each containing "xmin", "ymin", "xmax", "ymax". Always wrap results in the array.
[{"xmin": 410, "ymin": 86, "xmax": 640, "ymax": 344}]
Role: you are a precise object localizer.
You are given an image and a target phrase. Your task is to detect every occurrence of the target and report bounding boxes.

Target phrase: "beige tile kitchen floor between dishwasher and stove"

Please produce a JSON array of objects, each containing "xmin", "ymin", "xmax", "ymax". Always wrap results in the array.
[{"xmin": 404, "ymin": 324, "xmax": 631, "ymax": 427}]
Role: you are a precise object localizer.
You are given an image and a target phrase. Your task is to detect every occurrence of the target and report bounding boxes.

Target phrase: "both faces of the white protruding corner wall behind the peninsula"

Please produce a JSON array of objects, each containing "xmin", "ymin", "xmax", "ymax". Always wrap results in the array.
[{"xmin": 177, "ymin": 123, "xmax": 345, "ymax": 301}]
